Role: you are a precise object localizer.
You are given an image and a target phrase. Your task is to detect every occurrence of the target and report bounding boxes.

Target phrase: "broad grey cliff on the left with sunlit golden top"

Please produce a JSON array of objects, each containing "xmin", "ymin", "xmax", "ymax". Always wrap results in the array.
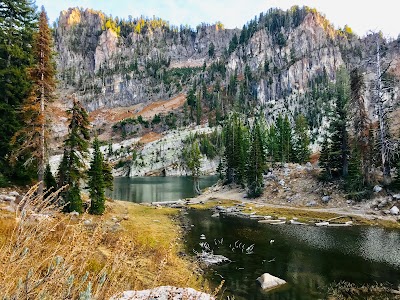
[{"xmin": 55, "ymin": 8, "xmax": 237, "ymax": 111}]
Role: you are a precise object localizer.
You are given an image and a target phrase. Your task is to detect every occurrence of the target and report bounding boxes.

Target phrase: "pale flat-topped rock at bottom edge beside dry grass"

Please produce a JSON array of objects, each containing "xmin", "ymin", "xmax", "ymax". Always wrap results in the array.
[{"xmin": 110, "ymin": 286, "xmax": 215, "ymax": 300}]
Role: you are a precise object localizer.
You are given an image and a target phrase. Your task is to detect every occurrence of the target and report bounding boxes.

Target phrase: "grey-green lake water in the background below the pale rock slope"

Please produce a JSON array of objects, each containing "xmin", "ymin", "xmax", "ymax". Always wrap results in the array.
[{"xmin": 107, "ymin": 176, "xmax": 218, "ymax": 203}]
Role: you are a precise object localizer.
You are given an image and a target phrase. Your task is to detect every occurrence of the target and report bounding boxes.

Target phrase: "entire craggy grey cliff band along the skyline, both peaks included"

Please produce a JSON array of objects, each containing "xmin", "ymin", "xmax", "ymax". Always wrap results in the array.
[{"xmin": 55, "ymin": 7, "xmax": 400, "ymax": 133}]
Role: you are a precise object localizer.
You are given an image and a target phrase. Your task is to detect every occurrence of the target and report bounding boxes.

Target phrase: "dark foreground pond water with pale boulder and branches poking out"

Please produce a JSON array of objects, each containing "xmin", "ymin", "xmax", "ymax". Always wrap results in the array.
[{"xmin": 186, "ymin": 210, "xmax": 400, "ymax": 300}]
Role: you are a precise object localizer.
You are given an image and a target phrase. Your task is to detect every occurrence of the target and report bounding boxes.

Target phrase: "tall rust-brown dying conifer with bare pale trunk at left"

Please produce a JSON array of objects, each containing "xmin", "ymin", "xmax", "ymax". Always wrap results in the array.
[{"xmin": 12, "ymin": 7, "xmax": 55, "ymax": 195}]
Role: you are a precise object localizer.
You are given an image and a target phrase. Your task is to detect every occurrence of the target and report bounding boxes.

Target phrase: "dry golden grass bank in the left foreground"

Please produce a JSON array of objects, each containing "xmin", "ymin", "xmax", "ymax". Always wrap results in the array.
[{"xmin": 0, "ymin": 184, "xmax": 202, "ymax": 299}]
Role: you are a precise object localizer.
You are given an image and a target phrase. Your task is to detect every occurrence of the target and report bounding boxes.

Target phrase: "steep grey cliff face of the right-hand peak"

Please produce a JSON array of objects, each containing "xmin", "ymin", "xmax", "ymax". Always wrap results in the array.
[{"xmin": 228, "ymin": 12, "xmax": 344, "ymax": 125}]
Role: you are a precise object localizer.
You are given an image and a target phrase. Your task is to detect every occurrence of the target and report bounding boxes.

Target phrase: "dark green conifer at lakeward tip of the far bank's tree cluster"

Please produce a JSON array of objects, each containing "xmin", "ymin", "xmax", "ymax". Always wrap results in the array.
[{"xmin": 247, "ymin": 120, "xmax": 265, "ymax": 198}]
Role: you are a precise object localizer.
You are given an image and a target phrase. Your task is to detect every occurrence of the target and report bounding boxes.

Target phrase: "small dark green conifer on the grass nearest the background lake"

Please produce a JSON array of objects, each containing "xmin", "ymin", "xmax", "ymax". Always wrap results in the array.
[{"xmin": 88, "ymin": 137, "xmax": 112, "ymax": 215}]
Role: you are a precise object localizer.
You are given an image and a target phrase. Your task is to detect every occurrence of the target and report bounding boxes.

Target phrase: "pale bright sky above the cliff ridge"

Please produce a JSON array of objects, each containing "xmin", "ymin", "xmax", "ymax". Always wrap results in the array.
[{"xmin": 36, "ymin": 0, "xmax": 400, "ymax": 38}]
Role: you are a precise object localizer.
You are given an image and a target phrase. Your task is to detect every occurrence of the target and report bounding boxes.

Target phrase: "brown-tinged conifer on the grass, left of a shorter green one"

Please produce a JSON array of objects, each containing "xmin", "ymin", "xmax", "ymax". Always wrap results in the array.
[{"xmin": 58, "ymin": 99, "xmax": 90, "ymax": 212}]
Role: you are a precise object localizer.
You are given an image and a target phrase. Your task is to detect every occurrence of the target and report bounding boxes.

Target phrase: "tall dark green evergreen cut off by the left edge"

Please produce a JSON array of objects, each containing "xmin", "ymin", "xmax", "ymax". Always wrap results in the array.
[{"xmin": 0, "ymin": 0, "xmax": 37, "ymax": 179}]
